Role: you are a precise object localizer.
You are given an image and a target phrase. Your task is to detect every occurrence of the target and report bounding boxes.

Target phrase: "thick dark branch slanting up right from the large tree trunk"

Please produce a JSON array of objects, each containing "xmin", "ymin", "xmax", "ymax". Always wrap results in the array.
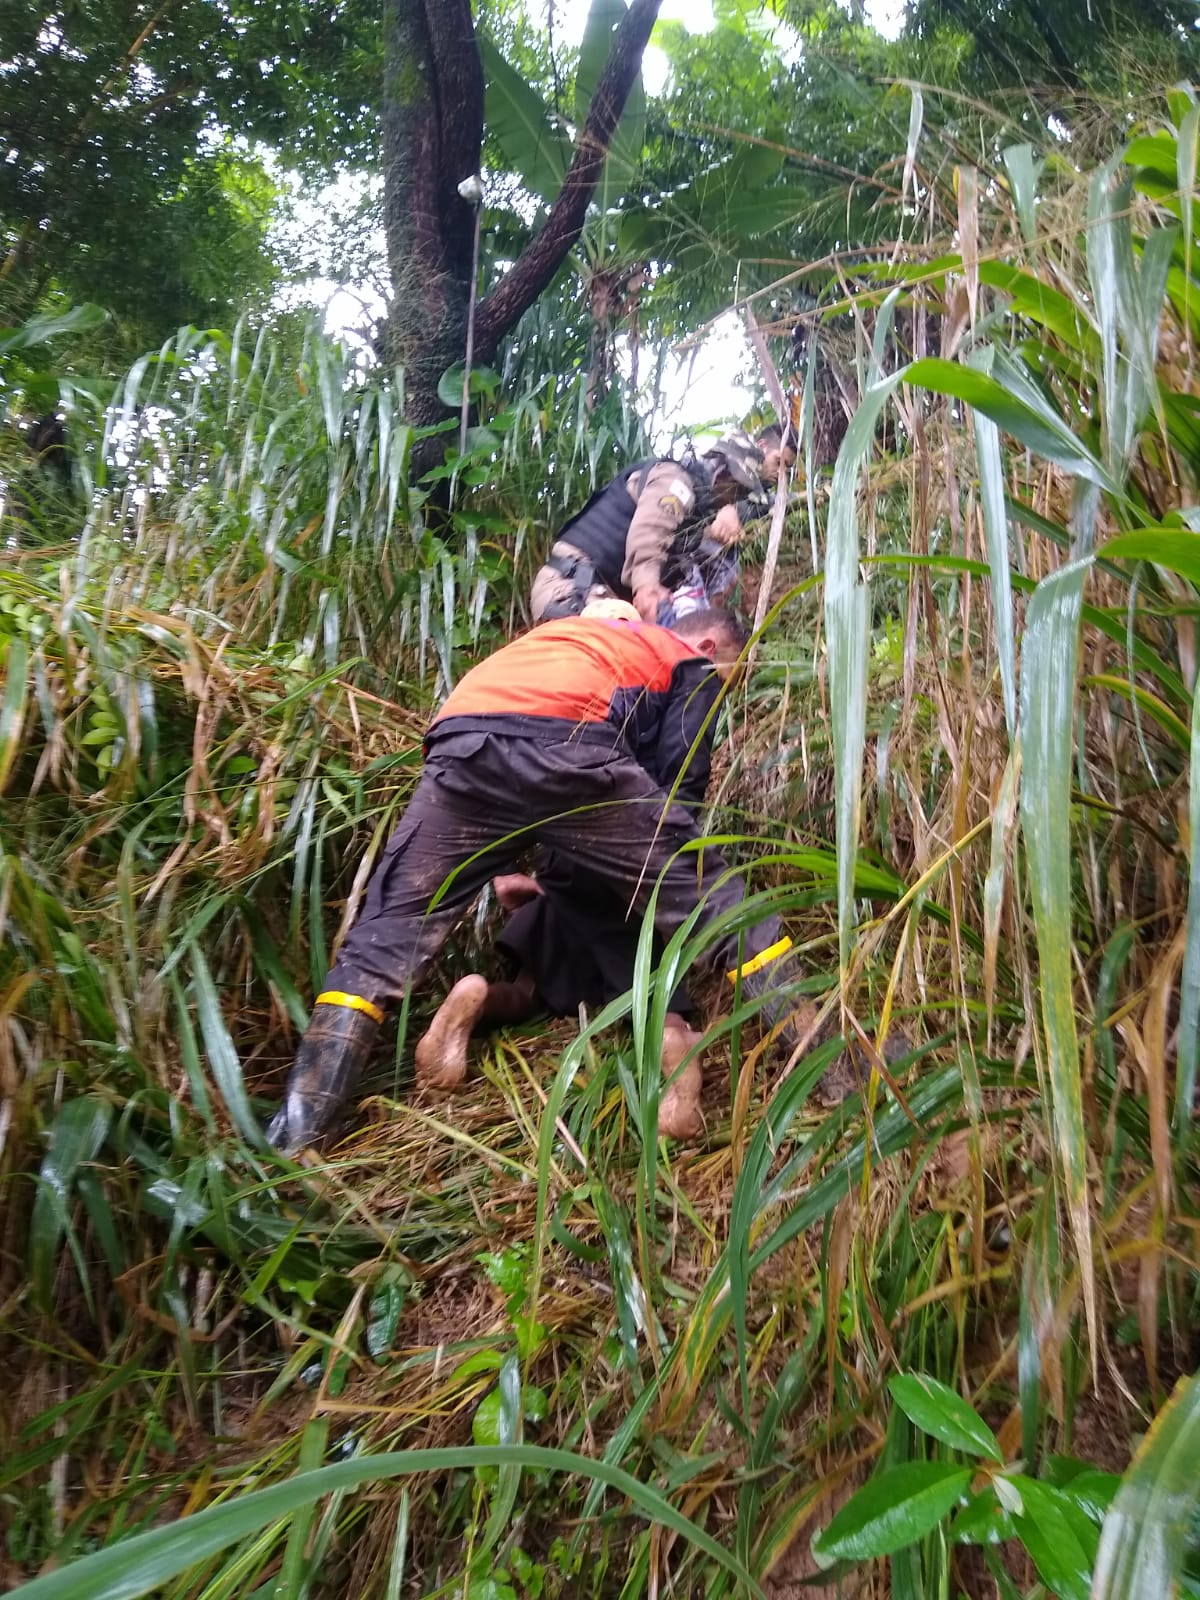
[{"xmin": 475, "ymin": 0, "xmax": 662, "ymax": 362}]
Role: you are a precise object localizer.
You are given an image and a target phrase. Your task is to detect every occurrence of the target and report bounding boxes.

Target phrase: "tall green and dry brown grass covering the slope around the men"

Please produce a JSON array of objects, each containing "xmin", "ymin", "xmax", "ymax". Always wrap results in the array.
[{"xmin": 0, "ymin": 88, "xmax": 1200, "ymax": 1600}]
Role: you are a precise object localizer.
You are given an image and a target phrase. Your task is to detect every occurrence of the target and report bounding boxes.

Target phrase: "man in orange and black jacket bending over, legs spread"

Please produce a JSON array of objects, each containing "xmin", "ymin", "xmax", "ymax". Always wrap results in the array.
[{"xmin": 267, "ymin": 611, "xmax": 803, "ymax": 1152}]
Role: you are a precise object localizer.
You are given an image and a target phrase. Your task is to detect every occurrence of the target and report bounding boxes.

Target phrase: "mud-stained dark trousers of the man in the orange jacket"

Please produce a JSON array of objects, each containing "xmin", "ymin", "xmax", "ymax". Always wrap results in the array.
[{"xmin": 326, "ymin": 731, "xmax": 790, "ymax": 1005}]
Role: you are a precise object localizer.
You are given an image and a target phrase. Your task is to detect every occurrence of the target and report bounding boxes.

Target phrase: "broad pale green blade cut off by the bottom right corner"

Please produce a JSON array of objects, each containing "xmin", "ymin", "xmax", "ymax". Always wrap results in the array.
[{"xmin": 1091, "ymin": 1374, "xmax": 1200, "ymax": 1600}]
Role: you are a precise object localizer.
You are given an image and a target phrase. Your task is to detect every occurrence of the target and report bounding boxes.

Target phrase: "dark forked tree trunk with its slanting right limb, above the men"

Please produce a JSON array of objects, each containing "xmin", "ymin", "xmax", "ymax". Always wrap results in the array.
[{"xmin": 382, "ymin": 0, "xmax": 661, "ymax": 477}]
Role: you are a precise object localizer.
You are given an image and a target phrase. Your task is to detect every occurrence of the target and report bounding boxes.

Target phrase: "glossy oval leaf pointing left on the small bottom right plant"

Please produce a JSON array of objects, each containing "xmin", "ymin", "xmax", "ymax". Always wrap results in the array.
[{"xmin": 813, "ymin": 1461, "xmax": 971, "ymax": 1566}]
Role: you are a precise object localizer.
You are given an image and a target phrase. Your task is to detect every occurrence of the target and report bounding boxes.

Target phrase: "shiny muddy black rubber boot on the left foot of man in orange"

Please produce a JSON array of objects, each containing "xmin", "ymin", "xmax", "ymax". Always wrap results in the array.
[{"xmin": 267, "ymin": 1002, "xmax": 384, "ymax": 1155}]
